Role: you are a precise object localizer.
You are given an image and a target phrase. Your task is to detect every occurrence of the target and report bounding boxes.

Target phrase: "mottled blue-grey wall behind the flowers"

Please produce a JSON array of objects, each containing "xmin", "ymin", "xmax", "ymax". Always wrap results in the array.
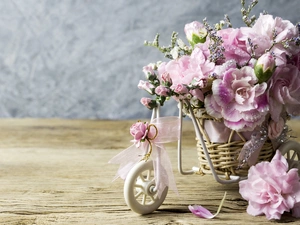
[{"xmin": 0, "ymin": 0, "xmax": 300, "ymax": 119}]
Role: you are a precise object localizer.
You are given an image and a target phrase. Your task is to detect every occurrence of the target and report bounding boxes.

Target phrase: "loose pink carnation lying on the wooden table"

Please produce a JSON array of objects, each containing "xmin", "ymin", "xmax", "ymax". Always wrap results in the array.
[{"xmin": 239, "ymin": 150, "xmax": 300, "ymax": 220}]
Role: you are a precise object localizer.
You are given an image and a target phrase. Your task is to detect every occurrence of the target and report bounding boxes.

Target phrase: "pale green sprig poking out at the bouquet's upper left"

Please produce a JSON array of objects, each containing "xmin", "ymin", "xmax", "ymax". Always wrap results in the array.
[{"xmin": 144, "ymin": 32, "xmax": 192, "ymax": 59}]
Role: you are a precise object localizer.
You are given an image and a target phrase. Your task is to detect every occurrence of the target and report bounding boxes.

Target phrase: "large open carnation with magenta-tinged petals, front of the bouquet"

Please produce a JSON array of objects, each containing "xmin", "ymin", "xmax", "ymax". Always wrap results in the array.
[{"xmin": 204, "ymin": 66, "xmax": 268, "ymax": 131}]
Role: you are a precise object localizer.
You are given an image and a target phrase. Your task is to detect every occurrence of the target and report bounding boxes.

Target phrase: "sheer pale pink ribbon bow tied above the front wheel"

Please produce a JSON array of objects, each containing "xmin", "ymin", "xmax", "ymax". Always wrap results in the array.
[{"xmin": 109, "ymin": 116, "xmax": 180, "ymax": 198}]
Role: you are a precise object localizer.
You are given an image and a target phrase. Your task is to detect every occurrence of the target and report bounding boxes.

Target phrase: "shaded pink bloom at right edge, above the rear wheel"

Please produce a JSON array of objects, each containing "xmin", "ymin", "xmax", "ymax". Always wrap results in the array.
[{"xmin": 269, "ymin": 64, "xmax": 300, "ymax": 122}]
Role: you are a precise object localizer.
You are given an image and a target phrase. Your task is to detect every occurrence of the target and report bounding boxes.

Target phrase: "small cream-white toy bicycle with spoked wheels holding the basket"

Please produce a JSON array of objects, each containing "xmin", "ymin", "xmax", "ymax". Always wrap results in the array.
[{"xmin": 124, "ymin": 102, "xmax": 300, "ymax": 214}]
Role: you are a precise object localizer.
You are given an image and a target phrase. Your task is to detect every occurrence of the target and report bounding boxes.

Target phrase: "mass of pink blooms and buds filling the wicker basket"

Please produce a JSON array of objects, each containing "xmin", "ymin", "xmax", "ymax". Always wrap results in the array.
[{"xmin": 138, "ymin": 14, "xmax": 300, "ymax": 134}]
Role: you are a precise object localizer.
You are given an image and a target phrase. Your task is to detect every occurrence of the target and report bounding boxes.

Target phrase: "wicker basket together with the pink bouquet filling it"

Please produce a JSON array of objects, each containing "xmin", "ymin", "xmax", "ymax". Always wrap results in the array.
[{"xmin": 138, "ymin": 0, "xmax": 300, "ymax": 177}]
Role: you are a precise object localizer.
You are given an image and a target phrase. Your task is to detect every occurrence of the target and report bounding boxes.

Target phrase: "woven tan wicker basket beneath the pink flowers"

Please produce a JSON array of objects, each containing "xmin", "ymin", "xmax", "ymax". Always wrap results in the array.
[{"xmin": 191, "ymin": 109, "xmax": 274, "ymax": 179}]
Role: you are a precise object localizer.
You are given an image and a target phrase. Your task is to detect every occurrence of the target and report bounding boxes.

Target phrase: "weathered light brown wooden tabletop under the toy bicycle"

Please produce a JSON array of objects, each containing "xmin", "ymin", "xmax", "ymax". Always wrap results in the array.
[{"xmin": 0, "ymin": 119, "xmax": 300, "ymax": 225}]
